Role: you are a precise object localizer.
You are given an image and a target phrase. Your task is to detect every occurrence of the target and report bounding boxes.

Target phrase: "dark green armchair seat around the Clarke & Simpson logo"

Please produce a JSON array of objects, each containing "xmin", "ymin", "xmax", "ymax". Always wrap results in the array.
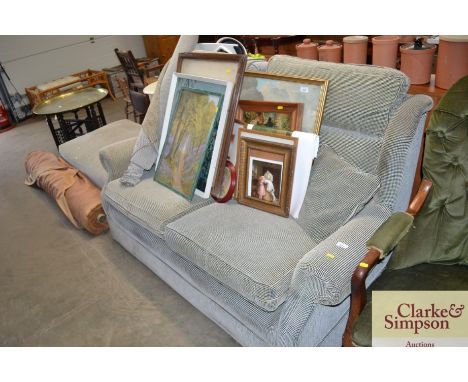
[{"xmin": 353, "ymin": 264, "xmax": 468, "ymax": 346}]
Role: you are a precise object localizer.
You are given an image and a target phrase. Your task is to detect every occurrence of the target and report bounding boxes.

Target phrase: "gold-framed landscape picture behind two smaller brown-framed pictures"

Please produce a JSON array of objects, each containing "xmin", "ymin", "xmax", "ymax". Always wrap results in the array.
[{"xmin": 240, "ymin": 72, "xmax": 328, "ymax": 135}]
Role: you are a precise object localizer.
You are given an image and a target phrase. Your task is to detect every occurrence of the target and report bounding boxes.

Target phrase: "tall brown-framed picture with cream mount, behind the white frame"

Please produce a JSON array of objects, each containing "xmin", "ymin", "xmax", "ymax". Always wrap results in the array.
[{"xmin": 177, "ymin": 52, "xmax": 247, "ymax": 193}]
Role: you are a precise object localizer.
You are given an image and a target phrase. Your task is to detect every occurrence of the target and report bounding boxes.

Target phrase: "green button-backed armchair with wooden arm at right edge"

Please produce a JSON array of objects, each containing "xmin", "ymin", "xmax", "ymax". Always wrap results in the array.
[{"xmin": 343, "ymin": 76, "xmax": 468, "ymax": 346}]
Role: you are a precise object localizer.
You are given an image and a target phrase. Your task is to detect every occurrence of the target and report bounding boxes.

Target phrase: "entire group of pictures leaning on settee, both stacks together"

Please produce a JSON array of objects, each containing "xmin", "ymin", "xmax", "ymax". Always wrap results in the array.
[{"xmin": 154, "ymin": 52, "xmax": 328, "ymax": 216}]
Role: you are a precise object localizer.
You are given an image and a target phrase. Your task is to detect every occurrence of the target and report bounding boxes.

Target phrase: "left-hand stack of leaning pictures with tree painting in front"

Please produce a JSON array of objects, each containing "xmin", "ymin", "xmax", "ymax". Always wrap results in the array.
[{"xmin": 154, "ymin": 52, "xmax": 247, "ymax": 200}]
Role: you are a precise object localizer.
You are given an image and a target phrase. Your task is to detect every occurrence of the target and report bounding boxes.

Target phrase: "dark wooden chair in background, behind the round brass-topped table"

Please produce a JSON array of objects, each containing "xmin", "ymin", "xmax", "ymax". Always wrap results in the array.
[{"xmin": 114, "ymin": 48, "xmax": 164, "ymax": 91}]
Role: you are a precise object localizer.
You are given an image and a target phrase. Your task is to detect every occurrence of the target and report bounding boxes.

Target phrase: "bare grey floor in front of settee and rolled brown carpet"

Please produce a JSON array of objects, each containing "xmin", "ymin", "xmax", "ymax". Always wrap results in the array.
[{"xmin": 0, "ymin": 99, "xmax": 237, "ymax": 346}]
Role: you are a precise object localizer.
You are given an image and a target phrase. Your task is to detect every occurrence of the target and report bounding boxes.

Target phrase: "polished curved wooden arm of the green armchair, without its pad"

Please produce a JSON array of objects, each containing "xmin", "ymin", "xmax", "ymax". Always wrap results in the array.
[{"xmin": 343, "ymin": 179, "xmax": 432, "ymax": 346}]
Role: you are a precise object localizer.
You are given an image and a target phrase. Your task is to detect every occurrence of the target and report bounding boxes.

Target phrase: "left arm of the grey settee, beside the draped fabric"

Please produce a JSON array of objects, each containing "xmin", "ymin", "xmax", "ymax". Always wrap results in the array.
[{"xmin": 99, "ymin": 137, "xmax": 137, "ymax": 182}]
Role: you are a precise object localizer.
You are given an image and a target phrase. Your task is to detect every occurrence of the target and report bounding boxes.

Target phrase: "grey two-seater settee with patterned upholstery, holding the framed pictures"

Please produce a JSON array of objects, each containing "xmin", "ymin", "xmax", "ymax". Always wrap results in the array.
[{"xmin": 100, "ymin": 55, "xmax": 432, "ymax": 346}]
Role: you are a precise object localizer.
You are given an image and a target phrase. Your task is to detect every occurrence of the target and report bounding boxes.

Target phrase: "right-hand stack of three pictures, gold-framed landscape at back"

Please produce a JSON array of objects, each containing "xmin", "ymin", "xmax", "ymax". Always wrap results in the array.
[{"xmin": 230, "ymin": 72, "xmax": 328, "ymax": 217}]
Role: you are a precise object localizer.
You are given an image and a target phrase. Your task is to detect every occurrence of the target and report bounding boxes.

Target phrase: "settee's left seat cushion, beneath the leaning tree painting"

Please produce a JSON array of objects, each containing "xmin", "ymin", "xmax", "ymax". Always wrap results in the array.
[{"xmin": 103, "ymin": 170, "xmax": 212, "ymax": 238}]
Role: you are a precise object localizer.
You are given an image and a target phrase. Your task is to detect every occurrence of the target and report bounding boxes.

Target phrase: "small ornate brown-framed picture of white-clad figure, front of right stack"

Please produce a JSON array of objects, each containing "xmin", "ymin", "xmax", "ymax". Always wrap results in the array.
[{"xmin": 237, "ymin": 129, "xmax": 297, "ymax": 217}]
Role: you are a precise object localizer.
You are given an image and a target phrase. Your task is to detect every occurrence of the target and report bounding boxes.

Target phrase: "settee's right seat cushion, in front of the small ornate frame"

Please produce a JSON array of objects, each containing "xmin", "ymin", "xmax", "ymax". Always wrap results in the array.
[{"xmin": 165, "ymin": 202, "xmax": 316, "ymax": 311}]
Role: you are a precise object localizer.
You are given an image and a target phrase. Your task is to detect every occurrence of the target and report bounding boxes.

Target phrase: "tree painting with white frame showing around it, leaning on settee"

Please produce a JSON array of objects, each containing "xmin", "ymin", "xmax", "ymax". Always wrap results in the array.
[{"xmin": 154, "ymin": 73, "xmax": 232, "ymax": 200}]
